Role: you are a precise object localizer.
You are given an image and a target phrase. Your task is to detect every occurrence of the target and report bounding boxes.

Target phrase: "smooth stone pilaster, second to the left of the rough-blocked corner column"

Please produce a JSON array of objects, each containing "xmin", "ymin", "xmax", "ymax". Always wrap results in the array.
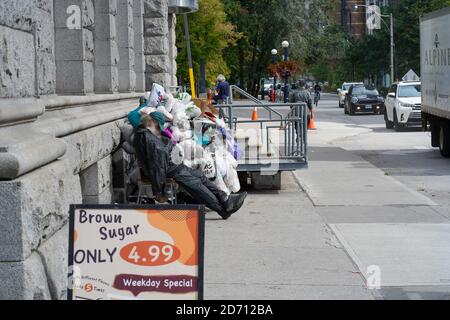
[{"xmin": 117, "ymin": 0, "xmax": 136, "ymax": 92}]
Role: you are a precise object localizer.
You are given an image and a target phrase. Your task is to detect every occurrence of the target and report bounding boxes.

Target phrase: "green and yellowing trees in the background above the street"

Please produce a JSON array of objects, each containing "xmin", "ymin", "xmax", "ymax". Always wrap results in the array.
[{"xmin": 177, "ymin": 0, "xmax": 450, "ymax": 94}]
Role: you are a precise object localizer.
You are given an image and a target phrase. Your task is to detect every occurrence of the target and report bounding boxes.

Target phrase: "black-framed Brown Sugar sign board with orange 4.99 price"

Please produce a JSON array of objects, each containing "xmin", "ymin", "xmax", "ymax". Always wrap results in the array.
[{"xmin": 68, "ymin": 205, "xmax": 205, "ymax": 300}]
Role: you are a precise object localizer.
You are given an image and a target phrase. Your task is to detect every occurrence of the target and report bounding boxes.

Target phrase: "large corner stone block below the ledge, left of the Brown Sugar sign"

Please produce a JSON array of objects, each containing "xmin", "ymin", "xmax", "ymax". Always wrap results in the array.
[{"xmin": 0, "ymin": 160, "xmax": 81, "ymax": 261}]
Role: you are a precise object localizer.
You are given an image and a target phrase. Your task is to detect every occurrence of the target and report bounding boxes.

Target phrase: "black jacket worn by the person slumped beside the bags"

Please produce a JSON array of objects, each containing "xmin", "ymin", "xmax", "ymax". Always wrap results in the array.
[{"xmin": 133, "ymin": 127, "xmax": 178, "ymax": 195}]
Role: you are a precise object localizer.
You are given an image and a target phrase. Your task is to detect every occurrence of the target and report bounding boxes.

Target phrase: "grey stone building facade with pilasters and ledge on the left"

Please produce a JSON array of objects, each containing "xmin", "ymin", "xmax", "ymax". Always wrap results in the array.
[{"xmin": 0, "ymin": 0, "xmax": 177, "ymax": 299}]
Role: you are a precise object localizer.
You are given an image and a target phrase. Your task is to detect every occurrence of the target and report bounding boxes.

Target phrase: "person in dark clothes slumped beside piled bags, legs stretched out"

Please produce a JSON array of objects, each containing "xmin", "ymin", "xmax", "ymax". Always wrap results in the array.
[{"xmin": 133, "ymin": 112, "xmax": 247, "ymax": 220}]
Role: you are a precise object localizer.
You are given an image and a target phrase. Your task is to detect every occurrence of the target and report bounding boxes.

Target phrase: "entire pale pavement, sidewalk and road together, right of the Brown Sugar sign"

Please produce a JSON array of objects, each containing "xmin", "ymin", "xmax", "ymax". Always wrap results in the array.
[{"xmin": 205, "ymin": 94, "xmax": 450, "ymax": 299}]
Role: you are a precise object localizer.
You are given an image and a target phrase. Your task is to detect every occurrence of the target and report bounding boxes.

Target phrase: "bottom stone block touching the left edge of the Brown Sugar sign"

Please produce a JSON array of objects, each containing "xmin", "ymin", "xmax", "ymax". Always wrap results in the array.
[{"xmin": 37, "ymin": 224, "xmax": 69, "ymax": 300}]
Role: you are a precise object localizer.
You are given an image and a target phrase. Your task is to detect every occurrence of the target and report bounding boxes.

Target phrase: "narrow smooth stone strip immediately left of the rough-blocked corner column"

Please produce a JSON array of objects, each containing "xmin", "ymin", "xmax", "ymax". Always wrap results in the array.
[{"xmin": 133, "ymin": 0, "xmax": 145, "ymax": 92}]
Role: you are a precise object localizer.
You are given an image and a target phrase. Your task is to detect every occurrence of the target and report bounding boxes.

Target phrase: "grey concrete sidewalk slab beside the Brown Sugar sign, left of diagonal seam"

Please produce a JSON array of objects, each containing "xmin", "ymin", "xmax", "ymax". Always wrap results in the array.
[{"xmin": 205, "ymin": 173, "xmax": 374, "ymax": 299}]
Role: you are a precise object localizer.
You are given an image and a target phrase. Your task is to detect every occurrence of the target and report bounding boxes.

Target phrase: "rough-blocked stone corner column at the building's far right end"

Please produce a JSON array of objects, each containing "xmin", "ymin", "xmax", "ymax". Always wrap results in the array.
[{"xmin": 144, "ymin": 0, "xmax": 171, "ymax": 90}]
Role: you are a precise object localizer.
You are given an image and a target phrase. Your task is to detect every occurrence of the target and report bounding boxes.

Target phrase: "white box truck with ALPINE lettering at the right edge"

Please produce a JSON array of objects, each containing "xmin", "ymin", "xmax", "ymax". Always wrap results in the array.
[{"xmin": 420, "ymin": 7, "xmax": 450, "ymax": 157}]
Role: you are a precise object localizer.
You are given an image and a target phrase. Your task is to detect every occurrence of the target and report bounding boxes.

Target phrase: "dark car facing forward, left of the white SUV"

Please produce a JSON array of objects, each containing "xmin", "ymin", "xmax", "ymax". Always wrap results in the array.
[{"xmin": 344, "ymin": 85, "xmax": 384, "ymax": 115}]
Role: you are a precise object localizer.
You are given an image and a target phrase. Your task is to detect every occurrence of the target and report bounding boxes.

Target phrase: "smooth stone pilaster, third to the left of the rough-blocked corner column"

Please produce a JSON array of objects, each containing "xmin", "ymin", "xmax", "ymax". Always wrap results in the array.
[{"xmin": 94, "ymin": 0, "xmax": 119, "ymax": 93}]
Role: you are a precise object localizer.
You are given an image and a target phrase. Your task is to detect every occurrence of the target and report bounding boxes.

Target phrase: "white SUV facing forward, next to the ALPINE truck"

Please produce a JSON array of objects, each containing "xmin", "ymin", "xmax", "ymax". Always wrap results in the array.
[{"xmin": 384, "ymin": 81, "xmax": 422, "ymax": 131}]
